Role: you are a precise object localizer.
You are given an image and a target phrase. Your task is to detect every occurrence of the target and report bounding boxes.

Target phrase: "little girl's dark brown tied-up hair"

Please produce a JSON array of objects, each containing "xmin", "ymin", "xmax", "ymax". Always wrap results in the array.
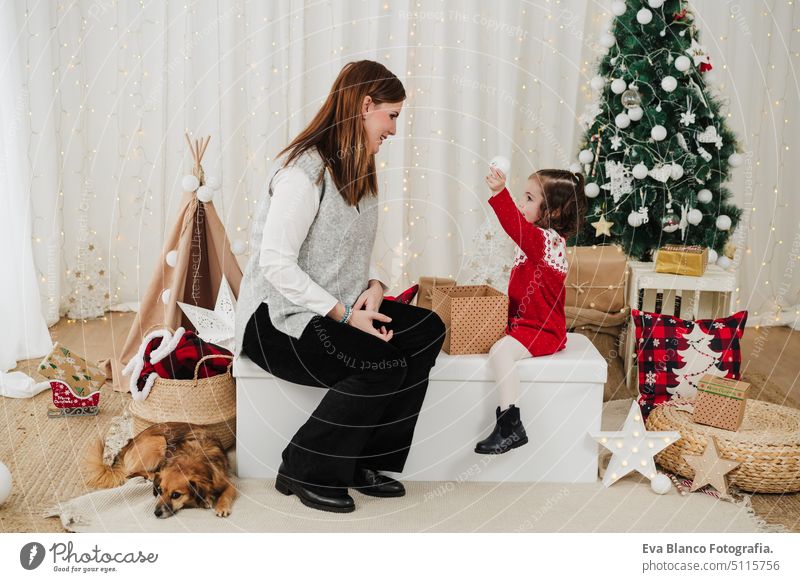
[{"xmin": 529, "ymin": 170, "xmax": 586, "ymax": 238}]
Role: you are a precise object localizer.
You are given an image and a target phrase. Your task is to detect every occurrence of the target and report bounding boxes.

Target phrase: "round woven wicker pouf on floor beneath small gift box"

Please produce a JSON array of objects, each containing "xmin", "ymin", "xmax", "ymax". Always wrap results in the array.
[{"xmin": 647, "ymin": 400, "xmax": 800, "ymax": 493}]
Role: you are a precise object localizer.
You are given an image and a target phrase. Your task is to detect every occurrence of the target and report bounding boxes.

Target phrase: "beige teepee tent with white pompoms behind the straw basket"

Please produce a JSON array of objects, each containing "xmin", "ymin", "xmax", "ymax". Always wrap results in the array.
[{"xmin": 101, "ymin": 135, "xmax": 242, "ymax": 392}]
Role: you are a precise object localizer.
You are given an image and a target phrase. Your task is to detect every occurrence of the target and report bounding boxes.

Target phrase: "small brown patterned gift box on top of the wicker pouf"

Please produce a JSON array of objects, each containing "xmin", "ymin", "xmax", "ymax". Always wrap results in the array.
[{"xmin": 692, "ymin": 374, "xmax": 750, "ymax": 431}]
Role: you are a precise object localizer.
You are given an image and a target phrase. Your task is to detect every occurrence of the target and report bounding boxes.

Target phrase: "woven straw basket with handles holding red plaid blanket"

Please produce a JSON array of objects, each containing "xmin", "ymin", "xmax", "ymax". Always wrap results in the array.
[{"xmin": 130, "ymin": 355, "xmax": 236, "ymax": 449}]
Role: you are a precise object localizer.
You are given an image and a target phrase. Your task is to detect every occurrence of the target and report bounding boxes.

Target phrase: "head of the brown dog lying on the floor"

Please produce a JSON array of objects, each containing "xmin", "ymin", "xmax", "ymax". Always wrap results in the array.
[{"xmin": 153, "ymin": 463, "xmax": 211, "ymax": 518}]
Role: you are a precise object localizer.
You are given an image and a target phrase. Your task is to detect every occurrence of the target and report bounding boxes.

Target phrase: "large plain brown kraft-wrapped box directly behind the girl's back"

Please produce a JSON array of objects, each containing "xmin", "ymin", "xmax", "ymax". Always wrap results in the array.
[{"xmin": 564, "ymin": 245, "xmax": 628, "ymax": 313}]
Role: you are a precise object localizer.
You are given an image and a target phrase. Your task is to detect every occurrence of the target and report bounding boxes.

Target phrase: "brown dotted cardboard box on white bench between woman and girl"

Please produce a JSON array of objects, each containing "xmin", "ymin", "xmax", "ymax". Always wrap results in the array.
[{"xmin": 432, "ymin": 285, "xmax": 508, "ymax": 355}]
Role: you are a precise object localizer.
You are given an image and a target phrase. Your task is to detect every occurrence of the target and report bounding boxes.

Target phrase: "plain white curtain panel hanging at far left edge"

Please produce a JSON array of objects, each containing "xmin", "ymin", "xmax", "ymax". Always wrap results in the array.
[{"xmin": 0, "ymin": 2, "xmax": 52, "ymax": 374}]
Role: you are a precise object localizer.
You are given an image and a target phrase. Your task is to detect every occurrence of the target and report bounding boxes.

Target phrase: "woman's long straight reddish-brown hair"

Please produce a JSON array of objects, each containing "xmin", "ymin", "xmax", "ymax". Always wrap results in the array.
[{"xmin": 278, "ymin": 61, "xmax": 406, "ymax": 206}]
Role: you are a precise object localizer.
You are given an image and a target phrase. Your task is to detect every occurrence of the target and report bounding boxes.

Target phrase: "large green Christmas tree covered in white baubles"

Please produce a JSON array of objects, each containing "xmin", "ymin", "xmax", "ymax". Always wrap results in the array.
[{"xmin": 572, "ymin": 0, "xmax": 742, "ymax": 260}]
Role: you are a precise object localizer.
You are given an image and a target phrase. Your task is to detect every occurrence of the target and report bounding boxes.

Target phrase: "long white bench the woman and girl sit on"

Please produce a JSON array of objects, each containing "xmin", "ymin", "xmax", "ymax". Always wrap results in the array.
[{"xmin": 233, "ymin": 334, "xmax": 607, "ymax": 483}]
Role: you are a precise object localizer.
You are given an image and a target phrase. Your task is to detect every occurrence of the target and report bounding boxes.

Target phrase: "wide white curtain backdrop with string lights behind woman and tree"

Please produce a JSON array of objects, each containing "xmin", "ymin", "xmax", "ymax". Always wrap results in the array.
[{"xmin": 15, "ymin": 0, "xmax": 800, "ymax": 324}]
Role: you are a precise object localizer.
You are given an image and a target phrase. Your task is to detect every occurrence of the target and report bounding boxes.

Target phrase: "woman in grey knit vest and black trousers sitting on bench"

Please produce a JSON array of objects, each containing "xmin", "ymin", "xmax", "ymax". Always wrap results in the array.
[{"xmin": 236, "ymin": 61, "xmax": 445, "ymax": 512}]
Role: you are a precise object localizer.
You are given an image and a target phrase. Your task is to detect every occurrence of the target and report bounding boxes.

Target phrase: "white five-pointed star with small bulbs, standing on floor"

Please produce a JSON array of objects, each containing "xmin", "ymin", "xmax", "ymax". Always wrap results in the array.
[{"xmin": 589, "ymin": 401, "xmax": 681, "ymax": 487}]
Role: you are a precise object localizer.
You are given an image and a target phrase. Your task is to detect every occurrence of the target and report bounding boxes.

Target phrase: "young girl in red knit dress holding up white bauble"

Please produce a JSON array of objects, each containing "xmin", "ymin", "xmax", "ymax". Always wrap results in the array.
[{"xmin": 475, "ymin": 167, "xmax": 586, "ymax": 455}]
